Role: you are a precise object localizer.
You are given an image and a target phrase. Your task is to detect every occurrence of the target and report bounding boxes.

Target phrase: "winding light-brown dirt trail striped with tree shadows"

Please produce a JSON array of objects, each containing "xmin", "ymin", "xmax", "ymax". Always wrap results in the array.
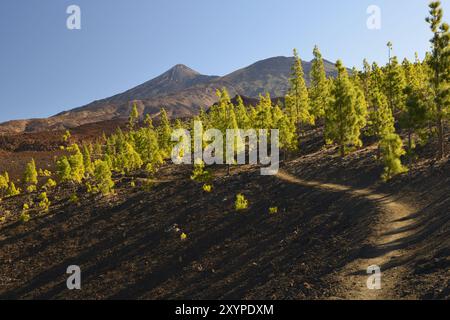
[{"xmin": 277, "ymin": 170, "xmax": 416, "ymax": 300}]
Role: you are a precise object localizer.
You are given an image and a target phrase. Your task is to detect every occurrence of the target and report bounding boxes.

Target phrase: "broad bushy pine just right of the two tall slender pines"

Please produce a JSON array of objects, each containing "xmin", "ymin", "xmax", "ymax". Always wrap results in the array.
[{"xmin": 325, "ymin": 60, "xmax": 367, "ymax": 157}]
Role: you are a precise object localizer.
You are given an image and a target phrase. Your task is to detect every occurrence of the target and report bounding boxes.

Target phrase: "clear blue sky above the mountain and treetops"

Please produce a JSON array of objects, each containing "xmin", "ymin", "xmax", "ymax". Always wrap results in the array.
[{"xmin": 0, "ymin": 0, "xmax": 450, "ymax": 121}]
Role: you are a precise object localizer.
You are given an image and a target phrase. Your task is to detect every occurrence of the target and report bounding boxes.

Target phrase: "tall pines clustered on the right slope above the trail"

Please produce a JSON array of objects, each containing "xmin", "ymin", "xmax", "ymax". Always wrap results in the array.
[{"xmin": 278, "ymin": 1, "xmax": 450, "ymax": 180}]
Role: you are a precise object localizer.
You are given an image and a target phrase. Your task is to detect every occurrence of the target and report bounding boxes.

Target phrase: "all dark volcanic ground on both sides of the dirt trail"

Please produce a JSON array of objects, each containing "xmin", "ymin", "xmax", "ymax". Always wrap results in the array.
[{"xmin": 0, "ymin": 129, "xmax": 450, "ymax": 299}]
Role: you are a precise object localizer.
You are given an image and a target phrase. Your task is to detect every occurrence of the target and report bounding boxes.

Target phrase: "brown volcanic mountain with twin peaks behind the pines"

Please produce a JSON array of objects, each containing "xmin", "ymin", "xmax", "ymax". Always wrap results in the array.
[{"xmin": 0, "ymin": 57, "xmax": 336, "ymax": 133}]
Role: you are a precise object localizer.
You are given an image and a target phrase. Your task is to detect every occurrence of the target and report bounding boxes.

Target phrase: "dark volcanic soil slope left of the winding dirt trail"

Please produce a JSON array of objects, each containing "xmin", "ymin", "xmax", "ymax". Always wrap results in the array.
[{"xmin": 0, "ymin": 164, "xmax": 375, "ymax": 299}]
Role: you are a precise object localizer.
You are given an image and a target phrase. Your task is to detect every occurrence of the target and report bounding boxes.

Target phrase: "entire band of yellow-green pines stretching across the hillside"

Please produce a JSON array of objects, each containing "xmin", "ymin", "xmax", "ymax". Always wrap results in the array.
[{"xmin": 0, "ymin": 1, "xmax": 450, "ymax": 219}]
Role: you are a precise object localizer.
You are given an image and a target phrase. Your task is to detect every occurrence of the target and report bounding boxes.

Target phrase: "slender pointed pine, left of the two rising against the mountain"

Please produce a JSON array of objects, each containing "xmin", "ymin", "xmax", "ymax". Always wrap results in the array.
[{"xmin": 285, "ymin": 49, "xmax": 314, "ymax": 124}]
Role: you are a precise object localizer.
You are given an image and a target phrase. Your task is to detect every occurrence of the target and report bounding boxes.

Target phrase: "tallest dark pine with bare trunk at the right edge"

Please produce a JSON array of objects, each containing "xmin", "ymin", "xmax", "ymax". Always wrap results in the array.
[{"xmin": 426, "ymin": 1, "xmax": 450, "ymax": 159}]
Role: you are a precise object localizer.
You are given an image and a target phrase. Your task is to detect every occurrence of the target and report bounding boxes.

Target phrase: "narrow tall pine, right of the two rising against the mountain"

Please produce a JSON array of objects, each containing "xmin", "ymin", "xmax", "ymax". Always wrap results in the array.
[{"xmin": 309, "ymin": 46, "xmax": 330, "ymax": 120}]
